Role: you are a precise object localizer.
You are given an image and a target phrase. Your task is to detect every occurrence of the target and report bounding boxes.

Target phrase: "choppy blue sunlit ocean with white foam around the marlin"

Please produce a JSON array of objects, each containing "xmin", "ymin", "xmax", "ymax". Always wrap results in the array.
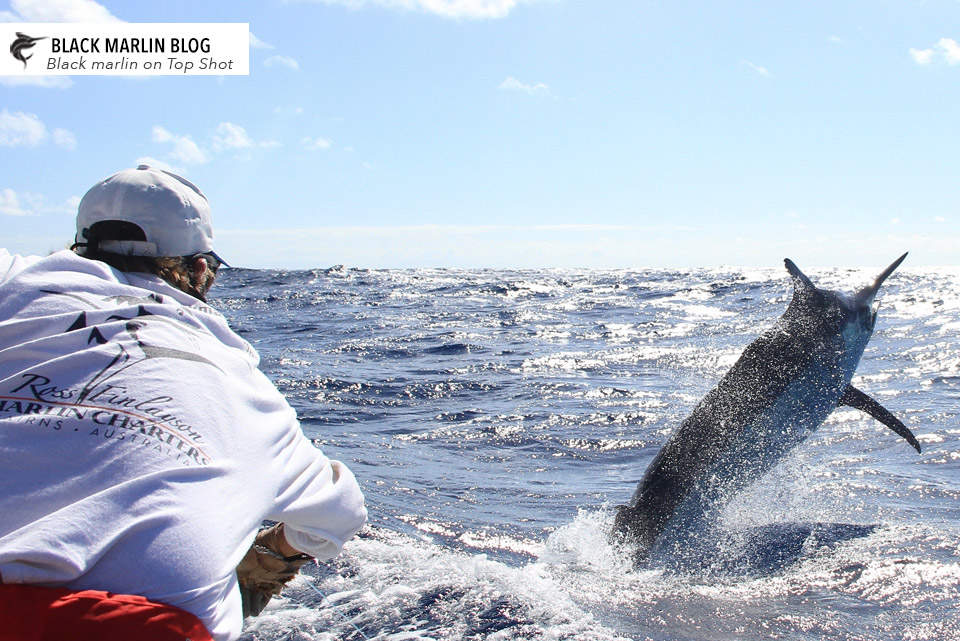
[{"xmin": 212, "ymin": 256, "xmax": 960, "ymax": 641}]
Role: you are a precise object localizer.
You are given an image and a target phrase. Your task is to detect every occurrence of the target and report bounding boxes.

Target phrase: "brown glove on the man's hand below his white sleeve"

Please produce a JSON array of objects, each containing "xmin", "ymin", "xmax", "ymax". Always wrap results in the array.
[{"xmin": 237, "ymin": 523, "xmax": 313, "ymax": 618}]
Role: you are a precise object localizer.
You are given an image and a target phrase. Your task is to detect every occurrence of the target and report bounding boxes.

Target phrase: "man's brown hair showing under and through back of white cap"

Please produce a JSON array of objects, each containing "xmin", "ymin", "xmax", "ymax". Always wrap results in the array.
[{"xmin": 72, "ymin": 220, "xmax": 216, "ymax": 302}]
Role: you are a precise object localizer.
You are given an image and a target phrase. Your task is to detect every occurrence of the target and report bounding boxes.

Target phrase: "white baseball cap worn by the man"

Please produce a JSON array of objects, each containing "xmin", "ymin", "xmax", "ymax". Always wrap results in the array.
[{"xmin": 76, "ymin": 165, "xmax": 223, "ymax": 262}]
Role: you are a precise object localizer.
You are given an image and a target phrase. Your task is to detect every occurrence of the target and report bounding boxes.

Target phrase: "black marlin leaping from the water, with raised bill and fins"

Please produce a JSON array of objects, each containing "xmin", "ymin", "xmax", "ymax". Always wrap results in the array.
[{"xmin": 614, "ymin": 254, "xmax": 920, "ymax": 560}]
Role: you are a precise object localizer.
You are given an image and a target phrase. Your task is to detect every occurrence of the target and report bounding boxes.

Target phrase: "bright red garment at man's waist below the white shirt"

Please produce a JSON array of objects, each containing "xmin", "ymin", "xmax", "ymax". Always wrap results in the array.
[{"xmin": 0, "ymin": 584, "xmax": 212, "ymax": 641}]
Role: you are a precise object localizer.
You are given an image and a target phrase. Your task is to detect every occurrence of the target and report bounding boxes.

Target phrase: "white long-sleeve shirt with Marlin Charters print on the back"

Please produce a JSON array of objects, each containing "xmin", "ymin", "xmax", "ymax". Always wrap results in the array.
[{"xmin": 0, "ymin": 249, "xmax": 366, "ymax": 640}]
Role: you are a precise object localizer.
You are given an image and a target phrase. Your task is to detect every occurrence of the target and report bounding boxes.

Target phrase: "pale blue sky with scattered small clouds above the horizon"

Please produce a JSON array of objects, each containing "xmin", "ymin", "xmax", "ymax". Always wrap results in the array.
[{"xmin": 0, "ymin": 0, "xmax": 960, "ymax": 269}]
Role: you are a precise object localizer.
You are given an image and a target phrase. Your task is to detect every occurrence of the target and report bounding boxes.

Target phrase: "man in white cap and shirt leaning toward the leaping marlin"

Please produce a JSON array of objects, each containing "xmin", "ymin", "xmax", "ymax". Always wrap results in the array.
[{"xmin": 0, "ymin": 165, "xmax": 366, "ymax": 641}]
